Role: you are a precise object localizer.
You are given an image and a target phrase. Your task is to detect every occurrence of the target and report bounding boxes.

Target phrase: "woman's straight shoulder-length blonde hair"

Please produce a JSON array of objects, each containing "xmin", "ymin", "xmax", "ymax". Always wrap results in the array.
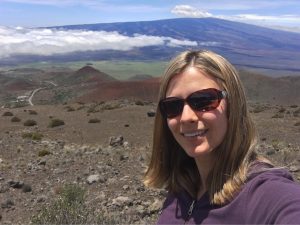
[{"xmin": 144, "ymin": 50, "xmax": 264, "ymax": 205}]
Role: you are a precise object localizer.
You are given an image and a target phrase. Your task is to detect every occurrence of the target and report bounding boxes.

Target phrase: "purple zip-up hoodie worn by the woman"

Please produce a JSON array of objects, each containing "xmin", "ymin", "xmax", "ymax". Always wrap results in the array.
[{"xmin": 157, "ymin": 169, "xmax": 300, "ymax": 224}]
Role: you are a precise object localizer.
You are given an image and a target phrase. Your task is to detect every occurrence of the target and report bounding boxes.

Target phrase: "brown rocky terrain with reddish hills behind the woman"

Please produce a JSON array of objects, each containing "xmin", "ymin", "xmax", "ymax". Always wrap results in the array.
[{"xmin": 0, "ymin": 66, "xmax": 300, "ymax": 224}]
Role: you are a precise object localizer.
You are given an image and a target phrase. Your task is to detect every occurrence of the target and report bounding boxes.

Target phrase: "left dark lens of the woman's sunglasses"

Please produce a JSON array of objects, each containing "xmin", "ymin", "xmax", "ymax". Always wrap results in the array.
[{"xmin": 160, "ymin": 98, "xmax": 184, "ymax": 118}]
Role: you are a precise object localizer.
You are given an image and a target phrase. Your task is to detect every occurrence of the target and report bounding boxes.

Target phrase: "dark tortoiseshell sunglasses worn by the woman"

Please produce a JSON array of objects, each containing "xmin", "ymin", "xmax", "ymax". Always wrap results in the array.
[{"xmin": 159, "ymin": 88, "xmax": 226, "ymax": 118}]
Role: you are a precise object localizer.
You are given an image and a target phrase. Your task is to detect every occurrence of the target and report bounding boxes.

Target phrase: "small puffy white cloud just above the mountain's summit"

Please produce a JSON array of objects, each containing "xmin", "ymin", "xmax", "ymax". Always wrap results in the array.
[{"xmin": 171, "ymin": 5, "xmax": 212, "ymax": 18}]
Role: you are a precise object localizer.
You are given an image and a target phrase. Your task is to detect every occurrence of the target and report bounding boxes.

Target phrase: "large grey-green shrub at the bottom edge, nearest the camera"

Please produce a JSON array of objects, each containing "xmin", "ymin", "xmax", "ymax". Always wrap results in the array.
[{"xmin": 31, "ymin": 184, "xmax": 137, "ymax": 225}]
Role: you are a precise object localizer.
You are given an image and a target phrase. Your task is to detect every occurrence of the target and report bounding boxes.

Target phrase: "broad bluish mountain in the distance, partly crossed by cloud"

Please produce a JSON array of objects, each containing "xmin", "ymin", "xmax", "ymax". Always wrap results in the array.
[{"xmin": 56, "ymin": 18, "xmax": 300, "ymax": 73}]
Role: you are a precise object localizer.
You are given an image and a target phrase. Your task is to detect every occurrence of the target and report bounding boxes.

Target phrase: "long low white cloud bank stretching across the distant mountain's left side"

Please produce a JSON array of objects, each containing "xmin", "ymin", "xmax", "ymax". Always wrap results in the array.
[{"xmin": 0, "ymin": 27, "xmax": 197, "ymax": 58}]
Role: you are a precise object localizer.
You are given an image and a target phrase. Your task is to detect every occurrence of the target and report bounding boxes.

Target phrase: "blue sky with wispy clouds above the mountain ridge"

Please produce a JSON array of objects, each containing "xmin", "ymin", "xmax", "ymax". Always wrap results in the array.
[{"xmin": 0, "ymin": 0, "xmax": 300, "ymax": 28}]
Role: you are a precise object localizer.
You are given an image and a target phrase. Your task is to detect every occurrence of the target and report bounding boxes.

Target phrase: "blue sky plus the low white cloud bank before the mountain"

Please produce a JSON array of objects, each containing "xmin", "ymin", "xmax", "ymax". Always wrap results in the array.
[{"xmin": 0, "ymin": 0, "xmax": 300, "ymax": 60}]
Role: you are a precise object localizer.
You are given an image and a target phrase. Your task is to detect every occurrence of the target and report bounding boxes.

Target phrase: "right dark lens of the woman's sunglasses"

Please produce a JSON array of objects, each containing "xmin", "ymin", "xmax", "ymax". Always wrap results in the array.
[{"xmin": 187, "ymin": 90, "xmax": 220, "ymax": 111}]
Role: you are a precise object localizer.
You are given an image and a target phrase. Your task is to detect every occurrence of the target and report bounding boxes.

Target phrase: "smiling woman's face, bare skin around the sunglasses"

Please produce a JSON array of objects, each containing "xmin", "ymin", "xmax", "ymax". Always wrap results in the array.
[{"xmin": 166, "ymin": 67, "xmax": 227, "ymax": 159}]
